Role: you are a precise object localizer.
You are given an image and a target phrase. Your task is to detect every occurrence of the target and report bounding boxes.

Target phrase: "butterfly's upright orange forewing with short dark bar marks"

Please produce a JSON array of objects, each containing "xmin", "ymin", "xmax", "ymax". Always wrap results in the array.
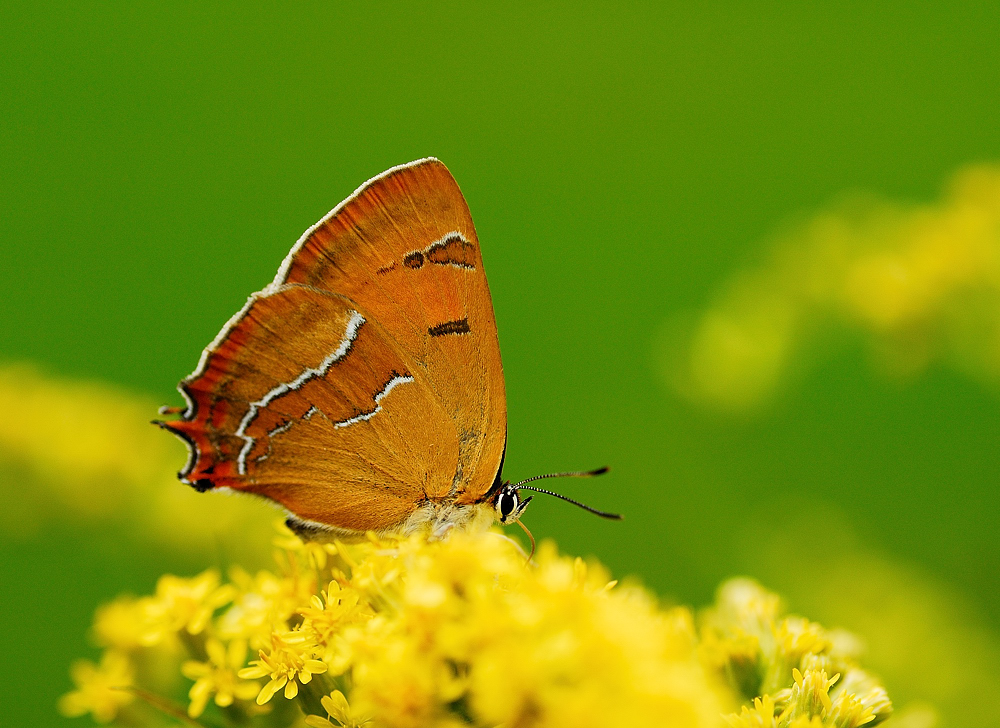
[{"xmin": 275, "ymin": 159, "xmax": 507, "ymax": 503}]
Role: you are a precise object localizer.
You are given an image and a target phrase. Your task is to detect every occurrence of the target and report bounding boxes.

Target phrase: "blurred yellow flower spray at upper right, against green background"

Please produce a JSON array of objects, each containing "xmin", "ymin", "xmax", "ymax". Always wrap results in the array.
[{"xmin": 665, "ymin": 165, "xmax": 1000, "ymax": 411}]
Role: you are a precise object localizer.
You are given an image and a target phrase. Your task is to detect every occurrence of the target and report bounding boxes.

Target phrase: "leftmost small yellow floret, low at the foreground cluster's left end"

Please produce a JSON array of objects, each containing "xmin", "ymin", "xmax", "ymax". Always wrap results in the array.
[{"xmin": 59, "ymin": 650, "xmax": 135, "ymax": 723}]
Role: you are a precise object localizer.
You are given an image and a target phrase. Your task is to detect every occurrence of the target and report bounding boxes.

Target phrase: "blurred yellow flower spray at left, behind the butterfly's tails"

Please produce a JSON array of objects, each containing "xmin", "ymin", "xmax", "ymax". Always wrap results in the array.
[{"xmin": 0, "ymin": 365, "xmax": 275, "ymax": 564}]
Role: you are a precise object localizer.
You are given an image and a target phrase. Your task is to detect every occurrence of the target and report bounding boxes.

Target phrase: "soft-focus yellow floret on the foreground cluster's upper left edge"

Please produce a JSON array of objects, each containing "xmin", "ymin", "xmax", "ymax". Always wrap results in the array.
[{"xmin": 143, "ymin": 569, "xmax": 236, "ymax": 645}]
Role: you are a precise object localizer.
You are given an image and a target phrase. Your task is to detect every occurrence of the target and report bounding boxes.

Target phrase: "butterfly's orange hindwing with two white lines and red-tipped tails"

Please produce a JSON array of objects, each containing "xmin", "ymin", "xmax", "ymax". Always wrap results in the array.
[{"xmin": 166, "ymin": 285, "xmax": 458, "ymax": 531}]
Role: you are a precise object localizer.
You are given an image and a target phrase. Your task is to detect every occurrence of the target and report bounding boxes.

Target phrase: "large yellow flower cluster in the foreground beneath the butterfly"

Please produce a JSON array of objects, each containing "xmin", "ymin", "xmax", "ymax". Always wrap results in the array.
[{"xmin": 61, "ymin": 531, "xmax": 891, "ymax": 728}]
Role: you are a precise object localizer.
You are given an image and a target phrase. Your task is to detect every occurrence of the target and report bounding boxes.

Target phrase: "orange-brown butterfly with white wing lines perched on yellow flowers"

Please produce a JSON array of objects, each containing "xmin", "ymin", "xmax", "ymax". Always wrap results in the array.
[{"xmin": 155, "ymin": 158, "xmax": 620, "ymax": 539}]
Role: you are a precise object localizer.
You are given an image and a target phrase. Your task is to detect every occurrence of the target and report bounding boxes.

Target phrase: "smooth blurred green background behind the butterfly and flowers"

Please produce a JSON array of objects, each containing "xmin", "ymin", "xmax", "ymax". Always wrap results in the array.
[{"xmin": 0, "ymin": 2, "xmax": 1000, "ymax": 725}]
